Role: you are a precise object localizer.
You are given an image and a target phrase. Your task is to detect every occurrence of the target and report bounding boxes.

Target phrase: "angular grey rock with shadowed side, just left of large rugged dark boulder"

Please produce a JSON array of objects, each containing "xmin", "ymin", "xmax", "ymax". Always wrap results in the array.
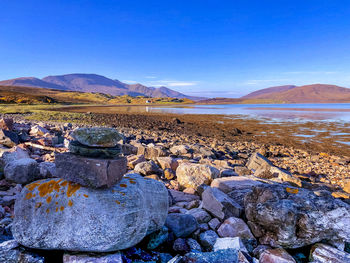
[{"xmin": 202, "ymin": 187, "xmax": 243, "ymax": 219}]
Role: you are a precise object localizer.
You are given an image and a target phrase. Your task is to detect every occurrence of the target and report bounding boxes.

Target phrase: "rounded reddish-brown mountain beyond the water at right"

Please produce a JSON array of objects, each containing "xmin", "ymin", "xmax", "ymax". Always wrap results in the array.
[{"xmin": 241, "ymin": 84, "xmax": 350, "ymax": 103}]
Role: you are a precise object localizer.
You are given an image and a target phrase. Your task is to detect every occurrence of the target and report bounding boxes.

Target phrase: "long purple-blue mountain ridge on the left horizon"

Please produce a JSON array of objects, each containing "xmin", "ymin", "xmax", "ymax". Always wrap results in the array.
[{"xmin": 0, "ymin": 74, "xmax": 203, "ymax": 100}]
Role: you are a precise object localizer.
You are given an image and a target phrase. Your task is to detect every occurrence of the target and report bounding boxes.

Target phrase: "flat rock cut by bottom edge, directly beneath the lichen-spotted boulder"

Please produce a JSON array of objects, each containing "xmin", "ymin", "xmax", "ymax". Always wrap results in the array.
[{"xmin": 63, "ymin": 252, "xmax": 123, "ymax": 263}]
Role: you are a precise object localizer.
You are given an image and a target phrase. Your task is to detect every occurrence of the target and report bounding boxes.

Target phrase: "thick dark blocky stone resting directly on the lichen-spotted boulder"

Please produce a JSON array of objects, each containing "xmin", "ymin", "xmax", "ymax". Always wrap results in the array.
[{"xmin": 55, "ymin": 153, "xmax": 127, "ymax": 188}]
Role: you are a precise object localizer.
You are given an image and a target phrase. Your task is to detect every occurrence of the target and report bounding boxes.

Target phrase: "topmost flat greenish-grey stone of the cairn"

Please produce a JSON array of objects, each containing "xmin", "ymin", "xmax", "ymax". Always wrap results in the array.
[{"xmin": 71, "ymin": 127, "xmax": 124, "ymax": 147}]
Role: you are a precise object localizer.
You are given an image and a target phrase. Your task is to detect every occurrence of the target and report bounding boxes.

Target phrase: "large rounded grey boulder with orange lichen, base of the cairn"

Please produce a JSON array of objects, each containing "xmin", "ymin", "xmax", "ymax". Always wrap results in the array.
[{"xmin": 12, "ymin": 174, "xmax": 168, "ymax": 252}]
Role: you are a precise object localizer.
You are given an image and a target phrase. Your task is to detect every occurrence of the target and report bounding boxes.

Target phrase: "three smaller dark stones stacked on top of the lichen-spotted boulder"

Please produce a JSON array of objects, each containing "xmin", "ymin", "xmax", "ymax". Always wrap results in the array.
[{"xmin": 55, "ymin": 128, "xmax": 127, "ymax": 188}]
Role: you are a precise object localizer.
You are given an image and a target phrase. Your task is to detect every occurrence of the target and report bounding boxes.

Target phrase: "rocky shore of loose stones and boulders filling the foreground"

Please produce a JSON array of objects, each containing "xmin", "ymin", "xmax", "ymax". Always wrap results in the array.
[{"xmin": 0, "ymin": 118, "xmax": 350, "ymax": 263}]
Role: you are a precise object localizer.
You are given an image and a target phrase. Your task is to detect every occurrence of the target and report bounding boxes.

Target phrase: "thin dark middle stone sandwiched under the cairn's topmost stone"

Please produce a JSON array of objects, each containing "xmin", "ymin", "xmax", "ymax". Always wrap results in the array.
[{"xmin": 68, "ymin": 141, "xmax": 122, "ymax": 158}]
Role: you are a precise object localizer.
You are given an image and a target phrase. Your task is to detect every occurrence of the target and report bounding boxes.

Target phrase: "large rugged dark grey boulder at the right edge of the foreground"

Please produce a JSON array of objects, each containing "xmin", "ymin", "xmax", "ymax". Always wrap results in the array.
[{"xmin": 244, "ymin": 185, "xmax": 350, "ymax": 248}]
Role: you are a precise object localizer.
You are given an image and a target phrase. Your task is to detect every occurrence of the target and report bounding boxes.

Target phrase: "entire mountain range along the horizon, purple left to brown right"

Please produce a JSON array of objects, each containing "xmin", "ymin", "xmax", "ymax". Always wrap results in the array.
[{"xmin": 0, "ymin": 74, "xmax": 350, "ymax": 104}]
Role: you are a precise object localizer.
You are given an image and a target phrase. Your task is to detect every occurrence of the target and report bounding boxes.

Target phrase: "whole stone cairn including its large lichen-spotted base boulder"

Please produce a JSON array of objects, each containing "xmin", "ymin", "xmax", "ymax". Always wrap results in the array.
[{"xmin": 12, "ymin": 128, "xmax": 168, "ymax": 252}]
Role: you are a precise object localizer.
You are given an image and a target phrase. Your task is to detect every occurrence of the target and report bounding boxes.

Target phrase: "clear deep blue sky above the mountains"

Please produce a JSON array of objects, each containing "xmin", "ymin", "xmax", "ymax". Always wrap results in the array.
[{"xmin": 0, "ymin": 0, "xmax": 350, "ymax": 97}]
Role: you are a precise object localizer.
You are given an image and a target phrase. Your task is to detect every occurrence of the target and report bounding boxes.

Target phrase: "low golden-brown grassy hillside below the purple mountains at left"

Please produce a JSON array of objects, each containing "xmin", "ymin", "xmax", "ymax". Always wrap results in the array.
[{"xmin": 0, "ymin": 86, "xmax": 193, "ymax": 104}]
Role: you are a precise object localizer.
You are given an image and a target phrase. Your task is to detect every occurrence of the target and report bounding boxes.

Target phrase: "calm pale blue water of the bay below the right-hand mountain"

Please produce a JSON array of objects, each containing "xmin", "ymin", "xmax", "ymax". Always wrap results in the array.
[{"xmin": 141, "ymin": 103, "xmax": 350, "ymax": 122}]
